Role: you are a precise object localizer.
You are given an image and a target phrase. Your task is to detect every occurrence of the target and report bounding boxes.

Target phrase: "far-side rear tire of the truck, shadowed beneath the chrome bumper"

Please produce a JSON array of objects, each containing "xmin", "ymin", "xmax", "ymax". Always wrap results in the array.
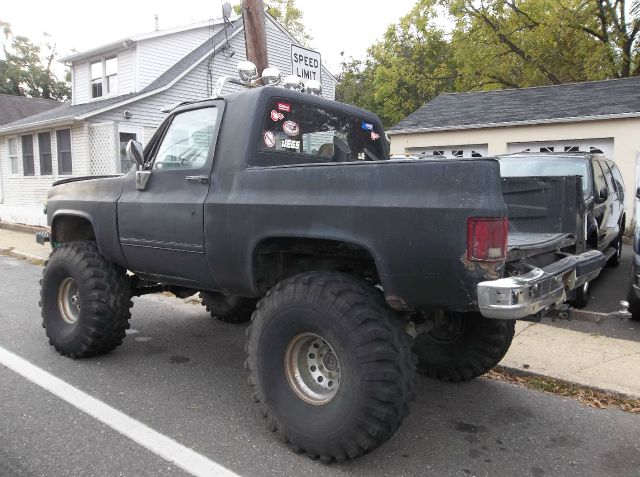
[{"xmin": 413, "ymin": 312, "xmax": 515, "ymax": 382}]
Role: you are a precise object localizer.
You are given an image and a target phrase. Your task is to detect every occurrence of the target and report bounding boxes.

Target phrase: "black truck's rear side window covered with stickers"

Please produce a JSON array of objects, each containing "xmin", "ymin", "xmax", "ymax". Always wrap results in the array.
[{"xmin": 259, "ymin": 99, "xmax": 386, "ymax": 164}]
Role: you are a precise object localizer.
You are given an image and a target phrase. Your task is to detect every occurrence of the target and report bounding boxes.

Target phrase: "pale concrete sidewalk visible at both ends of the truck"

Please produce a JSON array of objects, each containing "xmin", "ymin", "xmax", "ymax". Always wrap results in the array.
[{"xmin": 0, "ymin": 228, "xmax": 640, "ymax": 398}]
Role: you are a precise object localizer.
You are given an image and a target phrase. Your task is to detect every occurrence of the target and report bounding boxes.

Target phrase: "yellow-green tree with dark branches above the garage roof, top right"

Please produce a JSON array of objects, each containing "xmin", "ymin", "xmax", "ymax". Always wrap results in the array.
[{"xmin": 443, "ymin": 0, "xmax": 640, "ymax": 90}]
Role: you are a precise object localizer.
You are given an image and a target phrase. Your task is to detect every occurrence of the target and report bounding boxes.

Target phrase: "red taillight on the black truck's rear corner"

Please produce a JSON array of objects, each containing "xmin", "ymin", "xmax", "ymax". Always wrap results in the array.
[{"xmin": 467, "ymin": 217, "xmax": 509, "ymax": 262}]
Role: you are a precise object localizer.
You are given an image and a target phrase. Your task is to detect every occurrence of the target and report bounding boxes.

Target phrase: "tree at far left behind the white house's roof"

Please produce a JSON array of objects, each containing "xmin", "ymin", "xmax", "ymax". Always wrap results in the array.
[{"xmin": 0, "ymin": 22, "xmax": 71, "ymax": 100}]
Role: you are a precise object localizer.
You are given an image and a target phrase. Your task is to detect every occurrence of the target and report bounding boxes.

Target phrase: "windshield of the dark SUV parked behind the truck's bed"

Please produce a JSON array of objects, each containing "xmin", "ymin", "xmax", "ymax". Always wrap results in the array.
[{"xmin": 498, "ymin": 156, "xmax": 591, "ymax": 196}]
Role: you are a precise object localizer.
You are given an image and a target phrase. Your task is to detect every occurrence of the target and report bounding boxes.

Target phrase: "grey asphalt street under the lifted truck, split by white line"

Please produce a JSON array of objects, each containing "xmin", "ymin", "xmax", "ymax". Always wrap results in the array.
[{"xmin": 0, "ymin": 257, "xmax": 640, "ymax": 477}]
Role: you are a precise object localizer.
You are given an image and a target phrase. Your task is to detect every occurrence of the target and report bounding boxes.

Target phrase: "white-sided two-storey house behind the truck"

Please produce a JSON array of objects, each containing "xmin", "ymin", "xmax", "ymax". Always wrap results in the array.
[{"xmin": 0, "ymin": 15, "xmax": 336, "ymax": 225}]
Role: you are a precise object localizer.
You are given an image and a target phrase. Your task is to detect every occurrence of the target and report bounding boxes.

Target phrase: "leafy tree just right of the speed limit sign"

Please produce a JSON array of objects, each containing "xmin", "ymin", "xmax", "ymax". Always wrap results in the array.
[{"xmin": 336, "ymin": 0, "xmax": 457, "ymax": 126}]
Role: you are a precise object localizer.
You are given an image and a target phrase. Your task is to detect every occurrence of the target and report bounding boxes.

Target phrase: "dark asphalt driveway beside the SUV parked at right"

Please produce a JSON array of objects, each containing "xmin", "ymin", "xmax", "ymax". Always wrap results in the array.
[{"xmin": 543, "ymin": 245, "xmax": 640, "ymax": 340}]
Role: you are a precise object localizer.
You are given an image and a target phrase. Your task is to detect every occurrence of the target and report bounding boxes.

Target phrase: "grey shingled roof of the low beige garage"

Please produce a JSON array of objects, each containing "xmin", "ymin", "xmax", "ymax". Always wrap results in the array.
[{"xmin": 388, "ymin": 77, "xmax": 640, "ymax": 134}]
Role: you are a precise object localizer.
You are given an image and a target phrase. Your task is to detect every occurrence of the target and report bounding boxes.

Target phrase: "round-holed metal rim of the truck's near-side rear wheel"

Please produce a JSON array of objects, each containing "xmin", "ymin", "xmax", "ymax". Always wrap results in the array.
[{"xmin": 284, "ymin": 333, "xmax": 340, "ymax": 406}]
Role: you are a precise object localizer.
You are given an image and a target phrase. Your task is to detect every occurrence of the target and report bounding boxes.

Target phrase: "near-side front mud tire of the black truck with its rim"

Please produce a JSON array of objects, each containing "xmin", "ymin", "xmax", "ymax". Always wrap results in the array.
[{"xmin": 40, "ymin": 242, "xmax": 133, "ymax": 359}]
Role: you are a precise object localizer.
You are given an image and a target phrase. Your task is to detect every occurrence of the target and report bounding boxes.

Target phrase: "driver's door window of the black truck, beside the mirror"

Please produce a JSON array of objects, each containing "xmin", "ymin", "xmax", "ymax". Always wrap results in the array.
[{"xmin": 153, "ymin": 107, "xmax": 218, "ymax": 170}]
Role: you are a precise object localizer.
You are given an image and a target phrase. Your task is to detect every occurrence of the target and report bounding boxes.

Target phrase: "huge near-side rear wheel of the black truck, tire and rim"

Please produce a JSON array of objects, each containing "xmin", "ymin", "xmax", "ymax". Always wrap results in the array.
[{"xmin": 245, "ymin": 272, "xmax": 415, "ymax": 462}]
